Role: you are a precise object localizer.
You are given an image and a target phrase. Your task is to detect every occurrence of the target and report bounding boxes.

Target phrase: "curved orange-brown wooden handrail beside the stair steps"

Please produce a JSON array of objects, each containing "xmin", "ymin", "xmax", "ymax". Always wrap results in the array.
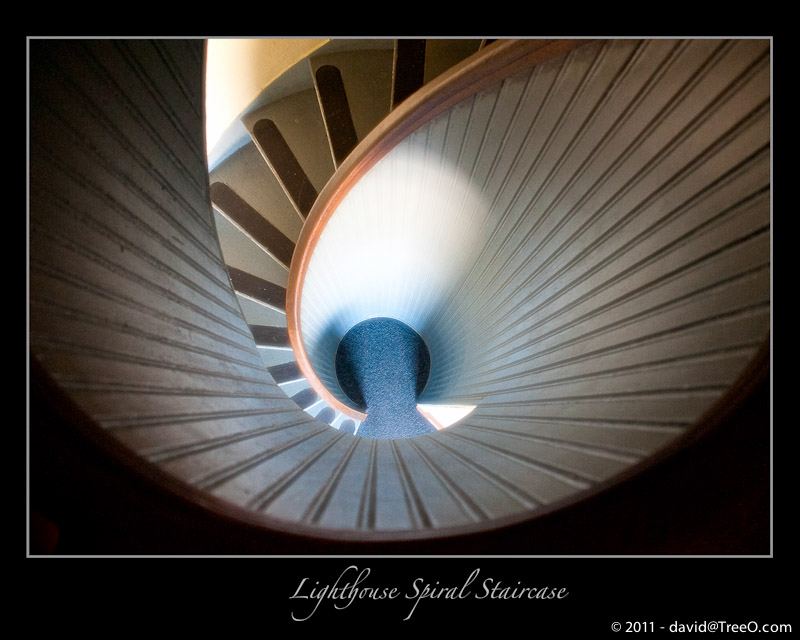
[{"xmin": 286, "ymin": 40, "xmax": 591, "ymax": 421}]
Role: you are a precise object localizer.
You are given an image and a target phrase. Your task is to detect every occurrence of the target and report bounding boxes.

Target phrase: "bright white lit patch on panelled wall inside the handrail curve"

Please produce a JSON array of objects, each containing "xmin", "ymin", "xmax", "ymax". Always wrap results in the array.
[{"xmin": 302, "ymin": 134, "xmax": 488, "ymax": 343}]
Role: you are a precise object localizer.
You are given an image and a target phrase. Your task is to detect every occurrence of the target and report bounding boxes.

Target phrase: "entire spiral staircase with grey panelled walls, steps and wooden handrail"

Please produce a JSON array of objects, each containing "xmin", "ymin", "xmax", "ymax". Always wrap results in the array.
[{"xmin": 30, "ymin": 40, "xmax": 771, "ymax": 544}]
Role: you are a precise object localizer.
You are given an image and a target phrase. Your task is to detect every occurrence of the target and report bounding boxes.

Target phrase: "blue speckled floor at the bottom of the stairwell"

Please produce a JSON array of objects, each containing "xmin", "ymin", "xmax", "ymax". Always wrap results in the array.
[{"xmin": 336, "ymin": 318, "xmax": 436, "ymax": 439}]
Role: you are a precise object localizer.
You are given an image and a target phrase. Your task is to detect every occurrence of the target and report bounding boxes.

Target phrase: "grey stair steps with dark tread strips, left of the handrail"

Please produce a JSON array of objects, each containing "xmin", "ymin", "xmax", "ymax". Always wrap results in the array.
[{"xmin": 211, "ymin": 40, "xmax": 479, "ymax": 424}]
